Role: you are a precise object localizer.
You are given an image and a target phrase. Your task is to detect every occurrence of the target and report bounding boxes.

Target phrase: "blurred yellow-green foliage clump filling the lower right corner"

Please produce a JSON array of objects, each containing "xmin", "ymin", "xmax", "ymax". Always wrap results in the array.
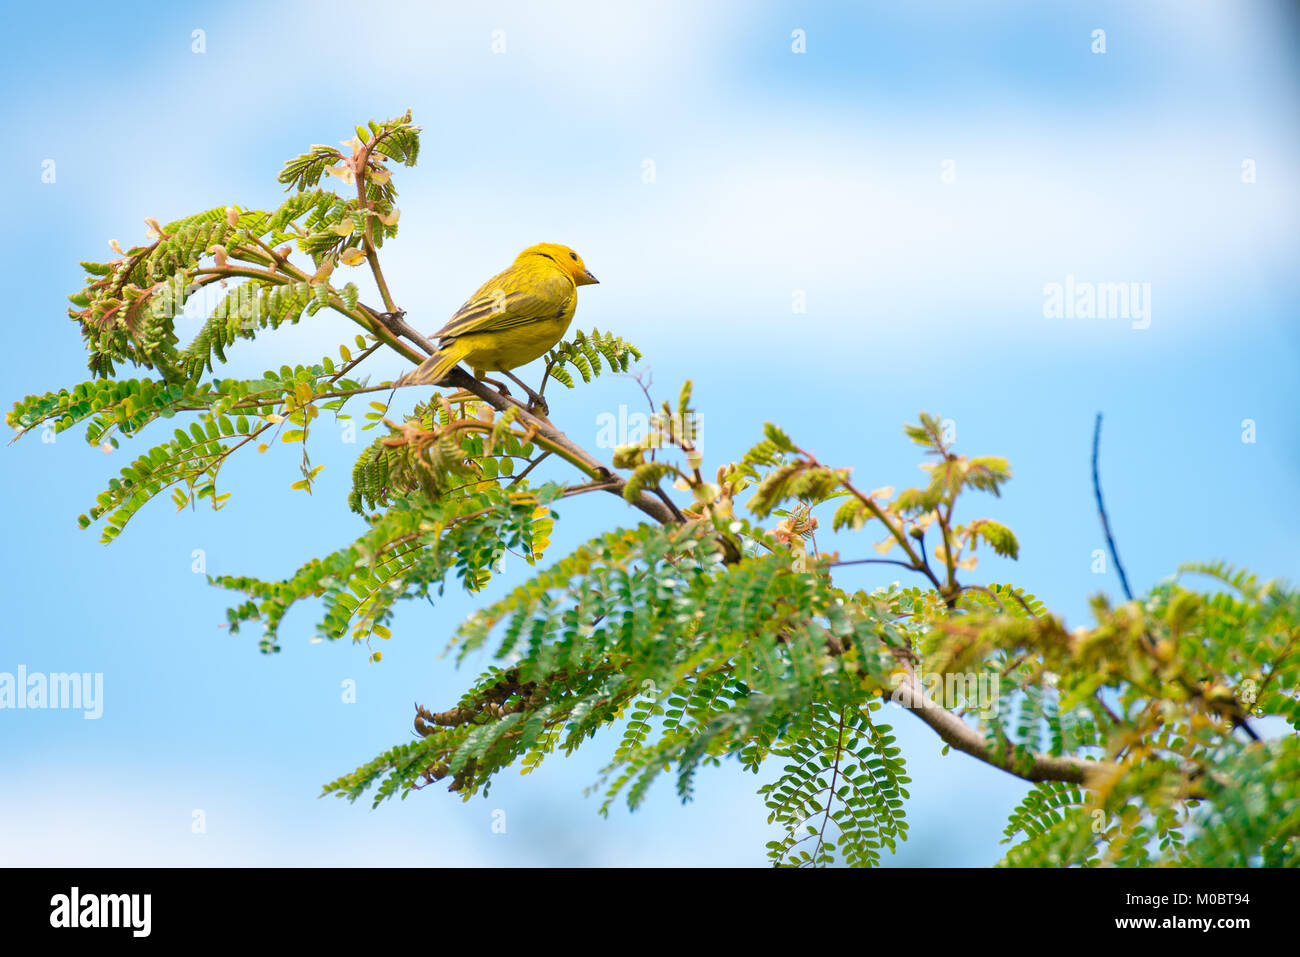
[{"xmin": 1005, "ymin": 564, "xmax": 1300, "ymax": 866}]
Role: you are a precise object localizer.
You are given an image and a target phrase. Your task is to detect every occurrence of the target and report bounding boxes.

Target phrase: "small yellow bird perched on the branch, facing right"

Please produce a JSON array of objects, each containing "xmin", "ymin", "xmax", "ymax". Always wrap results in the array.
[{"xmin": 399, "ymin": 243, "xmax": 597, "ymax": 412}]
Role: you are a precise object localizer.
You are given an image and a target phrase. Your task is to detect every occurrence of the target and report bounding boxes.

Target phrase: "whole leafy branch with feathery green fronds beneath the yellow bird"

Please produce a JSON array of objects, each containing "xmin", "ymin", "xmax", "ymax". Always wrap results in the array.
[{"xmin": 8, "ymin": 113, "xmax": 1300, "ymax": 866}]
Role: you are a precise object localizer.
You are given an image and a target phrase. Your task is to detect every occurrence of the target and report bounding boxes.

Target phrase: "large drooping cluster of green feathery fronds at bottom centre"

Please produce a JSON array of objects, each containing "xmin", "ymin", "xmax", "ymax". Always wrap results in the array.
[{"xmin": 318, "ymin": 514, "xmax": 907, "ymax": 863}]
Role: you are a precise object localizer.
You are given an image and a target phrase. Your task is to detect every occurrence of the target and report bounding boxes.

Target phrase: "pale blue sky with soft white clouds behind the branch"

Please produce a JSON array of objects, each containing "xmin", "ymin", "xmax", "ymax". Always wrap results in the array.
[{"xmin": 0, "ymin": 1, "xmax": 1300, "ymax": 866}]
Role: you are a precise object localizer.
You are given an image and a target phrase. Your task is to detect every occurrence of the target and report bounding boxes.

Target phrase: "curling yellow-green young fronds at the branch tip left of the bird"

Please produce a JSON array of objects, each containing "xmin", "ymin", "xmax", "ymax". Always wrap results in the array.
[{"xmin": 69, "ymin": 113, "xmax": 420, "ymax": 381}]
